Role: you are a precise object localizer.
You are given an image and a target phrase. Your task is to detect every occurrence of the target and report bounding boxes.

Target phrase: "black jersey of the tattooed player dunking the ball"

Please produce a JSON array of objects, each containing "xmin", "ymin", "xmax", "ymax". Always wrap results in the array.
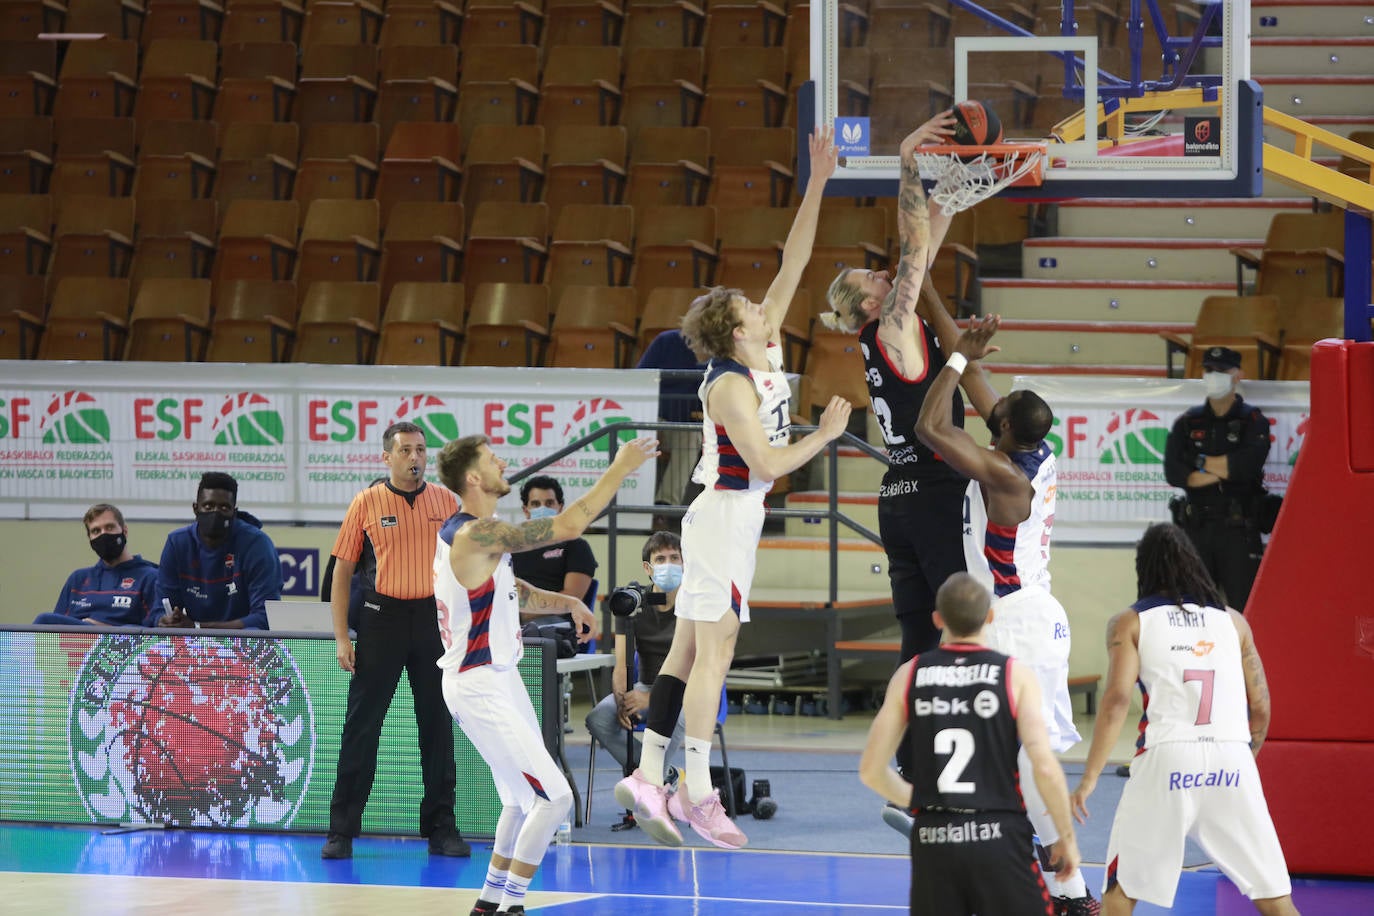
[{"xmin": 859, "ymin": 319, "xmax": 963, "ymax": 496}]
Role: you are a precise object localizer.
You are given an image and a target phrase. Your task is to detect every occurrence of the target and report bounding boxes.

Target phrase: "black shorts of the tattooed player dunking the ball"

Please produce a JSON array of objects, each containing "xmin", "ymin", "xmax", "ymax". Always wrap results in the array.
[{"xmin": 878, "ymin": 475, "xmax": 969, "ymax": 617}]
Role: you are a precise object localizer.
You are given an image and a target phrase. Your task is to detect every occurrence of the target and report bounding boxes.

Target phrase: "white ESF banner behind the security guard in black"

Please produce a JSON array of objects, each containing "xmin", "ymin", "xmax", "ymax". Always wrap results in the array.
[{"xmin": 1013, "ymin": 375, "xmax": 1309, "ymax": 542}]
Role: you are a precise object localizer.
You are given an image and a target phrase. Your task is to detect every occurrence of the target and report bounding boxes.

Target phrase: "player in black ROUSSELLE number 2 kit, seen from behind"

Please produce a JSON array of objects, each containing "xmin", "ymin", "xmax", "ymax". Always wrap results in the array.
[{"xmin": 859, "ymin": 573, "xmax": 1080, "ymax": 916}]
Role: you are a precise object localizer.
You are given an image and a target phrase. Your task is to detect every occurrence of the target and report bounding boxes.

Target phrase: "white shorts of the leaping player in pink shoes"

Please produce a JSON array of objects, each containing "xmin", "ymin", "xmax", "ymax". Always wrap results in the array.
[{"xmin": 673, "ymin": 490, "xmax": 764, "ymax": 623}]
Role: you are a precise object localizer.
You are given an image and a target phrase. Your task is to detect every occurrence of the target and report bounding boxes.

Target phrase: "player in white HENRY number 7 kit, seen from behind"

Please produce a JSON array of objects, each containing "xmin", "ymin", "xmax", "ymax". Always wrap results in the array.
[{"xmin": 1072, "ymin": 525, "xmax": 1297, "ymax": 916}]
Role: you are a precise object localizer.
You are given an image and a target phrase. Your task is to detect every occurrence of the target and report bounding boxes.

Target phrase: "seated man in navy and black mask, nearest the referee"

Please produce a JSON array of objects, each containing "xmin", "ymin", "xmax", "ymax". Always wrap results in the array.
[{"xmin": 157, "ymin": 471, "xmax": 282, "ymax": 630}]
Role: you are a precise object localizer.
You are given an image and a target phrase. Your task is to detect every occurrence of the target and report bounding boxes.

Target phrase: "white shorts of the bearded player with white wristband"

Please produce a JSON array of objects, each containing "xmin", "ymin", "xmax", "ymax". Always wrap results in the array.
[{"xmin": 982, "ymin": 586, "xmax": 1083, "ymax": 754}]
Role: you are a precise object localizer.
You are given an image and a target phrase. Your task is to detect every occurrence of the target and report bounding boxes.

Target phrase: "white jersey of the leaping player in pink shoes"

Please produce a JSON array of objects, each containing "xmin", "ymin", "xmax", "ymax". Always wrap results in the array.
[{"xmin": 692, "ymin": 343, "xmax": 791, "ymax": 493}]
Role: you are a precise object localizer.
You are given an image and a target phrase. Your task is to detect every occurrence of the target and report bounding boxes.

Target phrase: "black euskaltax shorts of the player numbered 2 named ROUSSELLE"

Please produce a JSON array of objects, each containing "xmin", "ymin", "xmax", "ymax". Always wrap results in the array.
[{"xmin": 911, "ymin": 812, "xmax": 1054, "ymax": 916}]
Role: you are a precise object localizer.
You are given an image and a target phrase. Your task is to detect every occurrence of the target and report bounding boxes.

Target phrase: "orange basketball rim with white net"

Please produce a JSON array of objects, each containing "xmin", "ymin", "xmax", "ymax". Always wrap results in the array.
[{"xmin": 912, "ymin": 143, "xmax": 1046, "ymax": 216}]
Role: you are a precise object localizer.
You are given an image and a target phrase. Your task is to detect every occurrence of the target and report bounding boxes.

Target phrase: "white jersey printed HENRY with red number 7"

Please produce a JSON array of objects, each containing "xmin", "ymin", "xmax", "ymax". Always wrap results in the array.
[{"xmin": 1132, "ymin": 596, "xmax": 1250, "ymax": 751}]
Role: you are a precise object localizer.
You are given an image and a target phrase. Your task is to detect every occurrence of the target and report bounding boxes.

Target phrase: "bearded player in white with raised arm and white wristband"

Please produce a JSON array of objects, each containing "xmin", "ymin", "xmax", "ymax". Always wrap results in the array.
[{"xmin": 916, "ymin": 316, "xmax": 1099, "ymax": 916}]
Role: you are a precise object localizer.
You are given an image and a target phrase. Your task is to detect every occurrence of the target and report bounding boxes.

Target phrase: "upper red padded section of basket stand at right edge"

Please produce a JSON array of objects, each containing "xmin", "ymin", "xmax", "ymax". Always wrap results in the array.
[{"xmin": 1245, "ymin": 341, "xmax": 1374, "ymax": 741}]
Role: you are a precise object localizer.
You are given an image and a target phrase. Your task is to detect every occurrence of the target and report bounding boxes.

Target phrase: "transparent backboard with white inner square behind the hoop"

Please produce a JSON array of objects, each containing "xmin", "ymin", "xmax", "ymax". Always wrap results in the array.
[{"xmin": 798, "ymin": 0, "xmax": 1263, "ymax": 199}]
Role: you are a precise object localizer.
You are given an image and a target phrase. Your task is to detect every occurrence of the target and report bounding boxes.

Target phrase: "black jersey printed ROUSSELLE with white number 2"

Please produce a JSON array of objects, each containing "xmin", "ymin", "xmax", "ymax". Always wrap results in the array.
[{"xmin": 907, "ymin": 643, "xmax": 1025, "ymax": 813}]
